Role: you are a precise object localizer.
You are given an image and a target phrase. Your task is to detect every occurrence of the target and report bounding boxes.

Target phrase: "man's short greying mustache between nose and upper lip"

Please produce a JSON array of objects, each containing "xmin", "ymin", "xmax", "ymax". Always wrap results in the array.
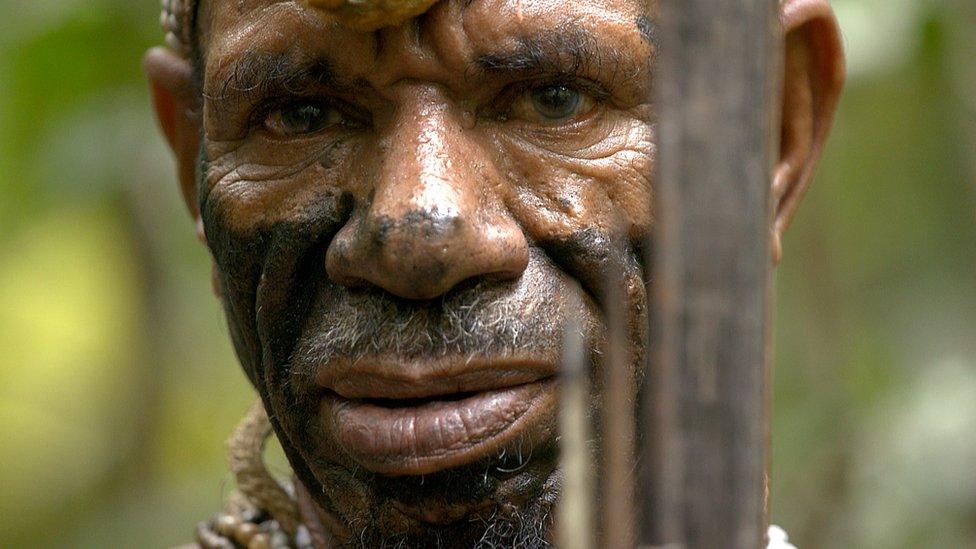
[{"xmin": 291, "ymin": 250, "xmax": 576, "ymax": 374}]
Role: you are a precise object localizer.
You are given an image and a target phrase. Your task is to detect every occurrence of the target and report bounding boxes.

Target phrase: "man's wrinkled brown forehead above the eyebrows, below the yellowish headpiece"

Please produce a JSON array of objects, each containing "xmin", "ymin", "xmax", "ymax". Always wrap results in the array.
[{"xmin": 197, "ymin": 0, "xmax": 657, "ymax": 80}]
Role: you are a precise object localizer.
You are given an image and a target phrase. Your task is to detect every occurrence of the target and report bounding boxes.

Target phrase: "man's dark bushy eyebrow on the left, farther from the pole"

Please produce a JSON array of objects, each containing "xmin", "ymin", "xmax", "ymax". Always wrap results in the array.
[{"xmin": 204, "ymin": 51, "xmax": 341, "ymax": 106}]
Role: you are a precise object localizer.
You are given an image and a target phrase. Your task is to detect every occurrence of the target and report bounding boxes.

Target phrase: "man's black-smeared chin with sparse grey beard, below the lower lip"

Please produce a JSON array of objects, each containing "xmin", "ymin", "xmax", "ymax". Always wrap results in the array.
[{"xmin": 302, "ymin": 442, "xmax": 560, "ymax": 547}]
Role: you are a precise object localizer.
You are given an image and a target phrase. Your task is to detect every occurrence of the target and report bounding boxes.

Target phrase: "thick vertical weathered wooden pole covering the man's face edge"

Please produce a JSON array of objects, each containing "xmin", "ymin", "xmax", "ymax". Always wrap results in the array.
[{"xmin": 641, "ymin": 0, "xmax": 782, "ymax": 549}]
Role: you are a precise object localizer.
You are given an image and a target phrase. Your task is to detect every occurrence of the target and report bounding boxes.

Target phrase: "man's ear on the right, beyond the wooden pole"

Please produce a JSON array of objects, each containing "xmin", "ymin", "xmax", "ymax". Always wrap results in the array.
[{"xmin": 771, "ymin": 0, "xmax": 845, "ymax": 264}]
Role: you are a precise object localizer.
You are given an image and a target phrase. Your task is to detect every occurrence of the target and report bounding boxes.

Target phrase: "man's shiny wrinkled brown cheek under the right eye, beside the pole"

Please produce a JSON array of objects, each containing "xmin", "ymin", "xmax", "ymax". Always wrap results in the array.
[{"xmin": 495, "ymin": 117, "xmax": 654, "ymax": 241}]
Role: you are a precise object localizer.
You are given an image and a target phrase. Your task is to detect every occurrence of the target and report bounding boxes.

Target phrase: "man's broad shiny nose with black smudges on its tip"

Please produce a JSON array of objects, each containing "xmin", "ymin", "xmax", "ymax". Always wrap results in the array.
[{"xmin": 326, "ymin": 89, "xmax": 529, "ymax": 299}]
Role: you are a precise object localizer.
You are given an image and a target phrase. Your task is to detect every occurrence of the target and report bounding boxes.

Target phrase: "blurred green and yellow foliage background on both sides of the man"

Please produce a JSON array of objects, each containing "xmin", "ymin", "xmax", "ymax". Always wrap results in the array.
[{"xmin": 0, "ymin": 0, "xmax": 976, "ymax": 548}]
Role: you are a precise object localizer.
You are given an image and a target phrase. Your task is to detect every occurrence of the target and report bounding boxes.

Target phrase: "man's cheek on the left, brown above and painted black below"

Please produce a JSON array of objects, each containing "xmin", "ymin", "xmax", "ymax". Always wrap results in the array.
[{"xmin": 200, "ymin": 137, "xmax": 360, "ymax": 386}]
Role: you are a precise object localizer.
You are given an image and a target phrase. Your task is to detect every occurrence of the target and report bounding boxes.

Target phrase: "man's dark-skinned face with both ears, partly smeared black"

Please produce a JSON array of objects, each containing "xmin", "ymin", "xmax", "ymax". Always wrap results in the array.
[{"xmin": 145, "ymin": 0, "xmax": 843, "ymax": 546}]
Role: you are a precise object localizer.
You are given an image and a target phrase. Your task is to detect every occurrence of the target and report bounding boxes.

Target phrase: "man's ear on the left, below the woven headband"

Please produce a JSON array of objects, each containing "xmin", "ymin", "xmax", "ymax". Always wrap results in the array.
[{"xmin": 142, "ymin": 47, "xmax": 206, "ymax": 242}]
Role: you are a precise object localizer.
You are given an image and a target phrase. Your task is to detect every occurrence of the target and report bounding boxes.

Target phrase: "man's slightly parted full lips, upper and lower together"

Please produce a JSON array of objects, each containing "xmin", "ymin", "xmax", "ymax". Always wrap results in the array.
[{"xmin": 316, "ymin": 361, "xmax": 555, "ymax": 475}]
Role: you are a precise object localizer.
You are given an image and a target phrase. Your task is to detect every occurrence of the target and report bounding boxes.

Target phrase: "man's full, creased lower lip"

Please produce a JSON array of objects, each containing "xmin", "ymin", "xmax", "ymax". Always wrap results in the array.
[{"xmin": 319, "ymin": 379, "xmax": 555, "ymax": 475}]
